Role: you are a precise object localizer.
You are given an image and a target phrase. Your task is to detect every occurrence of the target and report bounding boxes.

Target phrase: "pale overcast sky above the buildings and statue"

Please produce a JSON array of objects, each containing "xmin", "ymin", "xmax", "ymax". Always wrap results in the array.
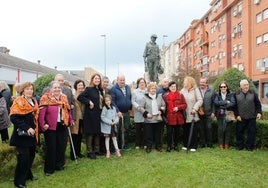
[{"xmin": 0, "ymin": 0, "xmax": 212, "ymax": 82}]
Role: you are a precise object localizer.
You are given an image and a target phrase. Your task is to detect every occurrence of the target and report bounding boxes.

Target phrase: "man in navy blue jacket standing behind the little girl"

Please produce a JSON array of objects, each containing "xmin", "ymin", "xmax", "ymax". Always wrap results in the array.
[{"xmin": 110, "ymin": 75, "xmax": 132, "ymax": 150}]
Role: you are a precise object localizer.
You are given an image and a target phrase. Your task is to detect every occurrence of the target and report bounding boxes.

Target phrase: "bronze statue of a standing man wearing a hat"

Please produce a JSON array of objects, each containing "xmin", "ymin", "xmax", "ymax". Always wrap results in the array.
[{"xmin": 143, "ymin": 35, "xmax": 164, "ymax": 83}]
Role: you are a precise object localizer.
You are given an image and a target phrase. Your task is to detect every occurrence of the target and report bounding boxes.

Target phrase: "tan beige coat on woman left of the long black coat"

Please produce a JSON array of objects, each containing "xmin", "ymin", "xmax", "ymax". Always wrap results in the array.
[{"xmin": 70, "ymin": 93, "xmax": 84, "ymax": 134}]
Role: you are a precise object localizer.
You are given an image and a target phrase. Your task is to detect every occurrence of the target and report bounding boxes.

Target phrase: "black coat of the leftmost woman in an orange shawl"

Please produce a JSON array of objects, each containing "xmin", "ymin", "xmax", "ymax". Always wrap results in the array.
[{"xmin": 10, "ymin": 113, "xmax": 36, "ymax": 147}]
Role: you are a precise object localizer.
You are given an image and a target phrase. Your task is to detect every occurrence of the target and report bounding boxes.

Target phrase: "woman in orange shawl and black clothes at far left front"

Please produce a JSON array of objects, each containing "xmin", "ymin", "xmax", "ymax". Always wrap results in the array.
[{"xmin": 10, "ymin": 82, "xmax": 39, "ymax": 187}]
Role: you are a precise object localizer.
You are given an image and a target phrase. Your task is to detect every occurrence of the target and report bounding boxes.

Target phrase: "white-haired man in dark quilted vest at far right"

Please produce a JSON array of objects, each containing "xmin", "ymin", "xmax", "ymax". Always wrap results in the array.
[{"xmin": 234, "ymin": 80, "xmax": 262, "ymax": 151}]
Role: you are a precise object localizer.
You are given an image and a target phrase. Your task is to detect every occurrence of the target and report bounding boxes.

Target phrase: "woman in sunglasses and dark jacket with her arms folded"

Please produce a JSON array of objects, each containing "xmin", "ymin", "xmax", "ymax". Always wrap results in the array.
[{"xmin": 214, "ymin": 81, "xmax": 235, "ymax": 149}]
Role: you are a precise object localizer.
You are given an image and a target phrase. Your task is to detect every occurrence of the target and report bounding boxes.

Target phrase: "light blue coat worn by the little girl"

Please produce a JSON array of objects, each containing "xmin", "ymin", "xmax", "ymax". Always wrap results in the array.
[{"xmin": 101, "ymin": 106, "xmax": 119, "ymax": 134}]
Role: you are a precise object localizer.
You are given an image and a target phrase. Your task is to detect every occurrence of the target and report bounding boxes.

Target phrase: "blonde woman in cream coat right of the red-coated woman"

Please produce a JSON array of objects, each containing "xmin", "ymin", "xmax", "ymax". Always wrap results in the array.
[{"xmin": 181, "ymin": 76, "xmax": 203, "ymax": 152}]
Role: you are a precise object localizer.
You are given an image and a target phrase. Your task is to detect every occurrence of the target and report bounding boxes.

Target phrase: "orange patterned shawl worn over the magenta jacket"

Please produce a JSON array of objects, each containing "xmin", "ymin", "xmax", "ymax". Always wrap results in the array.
[{"xmin": 39, "ymin": 92, "xmax": 71, "ymax": 126}]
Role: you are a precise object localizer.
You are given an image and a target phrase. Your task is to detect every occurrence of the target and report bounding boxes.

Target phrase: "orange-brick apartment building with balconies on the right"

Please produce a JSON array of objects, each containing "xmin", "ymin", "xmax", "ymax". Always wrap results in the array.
[{"xmin": 161, "ymin": 0, "xmax": 268, "ymax": 102}]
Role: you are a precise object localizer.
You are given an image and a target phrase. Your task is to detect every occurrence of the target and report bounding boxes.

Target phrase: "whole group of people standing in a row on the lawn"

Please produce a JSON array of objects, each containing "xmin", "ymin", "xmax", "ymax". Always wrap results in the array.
[{"xmin": 0, "ymin": 73, "xmax": 261, "ymax": 187}]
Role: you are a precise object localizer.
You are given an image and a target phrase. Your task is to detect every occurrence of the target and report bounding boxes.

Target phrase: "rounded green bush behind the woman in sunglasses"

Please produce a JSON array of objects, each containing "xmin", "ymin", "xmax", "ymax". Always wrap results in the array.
[{"xmin": 213, "ymin": 68, "xmax": 256, "ymax": 92}]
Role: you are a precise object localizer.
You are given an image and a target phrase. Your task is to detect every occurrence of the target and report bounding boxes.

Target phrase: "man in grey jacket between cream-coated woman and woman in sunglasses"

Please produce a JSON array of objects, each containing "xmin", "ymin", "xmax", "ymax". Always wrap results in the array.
[{"xmin": 199, "ymin": 77, "xmax": 215, "ymax": 147}]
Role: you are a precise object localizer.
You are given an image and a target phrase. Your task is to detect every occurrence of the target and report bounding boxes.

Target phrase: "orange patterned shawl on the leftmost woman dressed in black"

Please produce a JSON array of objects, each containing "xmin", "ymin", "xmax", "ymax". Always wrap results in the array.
[{"xmin": 10, "ymin": 96, "xmax": 39, "ymax": 142}]
